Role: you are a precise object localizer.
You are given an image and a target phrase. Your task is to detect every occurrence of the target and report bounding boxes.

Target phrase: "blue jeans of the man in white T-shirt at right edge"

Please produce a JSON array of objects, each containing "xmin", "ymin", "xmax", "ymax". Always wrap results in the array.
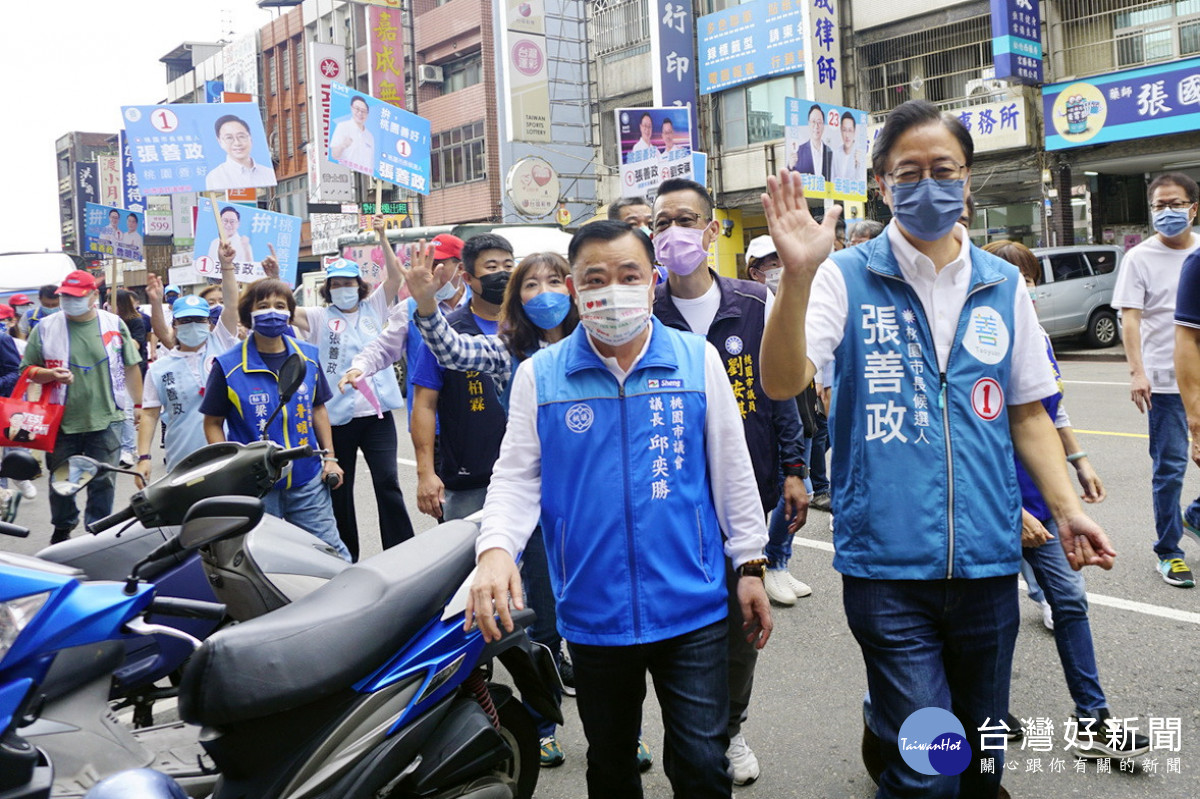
[{"xmin": 1146, "ymin": 394, "xmax": 1188, "ymax": 560}]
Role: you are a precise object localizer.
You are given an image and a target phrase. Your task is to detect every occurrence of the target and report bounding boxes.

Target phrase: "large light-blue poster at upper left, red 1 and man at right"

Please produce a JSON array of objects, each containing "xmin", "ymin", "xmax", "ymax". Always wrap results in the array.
[{"xmin": 121, "ymin": 103, "xmax": 276, "ymax": 194}]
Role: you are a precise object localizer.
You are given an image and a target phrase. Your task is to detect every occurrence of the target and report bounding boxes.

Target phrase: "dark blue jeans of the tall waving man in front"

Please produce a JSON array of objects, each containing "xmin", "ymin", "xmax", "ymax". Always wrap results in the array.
[{"xmin": 842, "ymin": 575, "xmax": 1020, "ymax": 799}]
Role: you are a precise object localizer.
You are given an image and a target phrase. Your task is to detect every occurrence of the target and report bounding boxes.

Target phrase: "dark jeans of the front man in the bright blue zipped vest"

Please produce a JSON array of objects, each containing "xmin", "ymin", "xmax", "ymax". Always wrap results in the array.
[{"xmin": 568, "ymin": 620, "xmax": 732, "ymax": 799}]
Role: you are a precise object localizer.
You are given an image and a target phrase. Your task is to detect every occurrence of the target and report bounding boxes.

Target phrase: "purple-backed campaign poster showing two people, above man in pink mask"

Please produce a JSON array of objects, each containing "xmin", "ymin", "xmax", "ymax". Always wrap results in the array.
[{"xmin": 616, "ymin": 107, "xmax": 692, "ymax": 199}]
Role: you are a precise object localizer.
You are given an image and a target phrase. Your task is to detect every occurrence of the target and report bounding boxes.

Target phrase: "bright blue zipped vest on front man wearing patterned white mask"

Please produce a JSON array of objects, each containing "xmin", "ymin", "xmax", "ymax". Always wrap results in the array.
[{"xmin": 533, "ymin": 320, "xmax": 728, "ymax": 645}]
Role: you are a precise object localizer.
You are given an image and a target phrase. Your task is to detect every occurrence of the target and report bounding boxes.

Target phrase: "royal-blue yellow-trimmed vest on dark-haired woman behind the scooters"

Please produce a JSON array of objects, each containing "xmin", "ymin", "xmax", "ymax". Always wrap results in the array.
[{"xmin": 217, "ymin": 335, "xmax": 320, "ymax": 488}]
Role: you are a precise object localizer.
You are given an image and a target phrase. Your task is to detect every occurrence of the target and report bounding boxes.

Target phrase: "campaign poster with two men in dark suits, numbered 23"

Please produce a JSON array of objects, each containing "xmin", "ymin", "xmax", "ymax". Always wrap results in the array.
[{"xmin": 784, "ymin": 97, "xmax": 870, "ymax": 202}]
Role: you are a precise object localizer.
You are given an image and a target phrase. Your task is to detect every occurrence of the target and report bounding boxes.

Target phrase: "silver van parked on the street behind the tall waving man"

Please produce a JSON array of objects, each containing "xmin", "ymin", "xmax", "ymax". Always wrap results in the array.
[{"xmin": 1033, "ymin": 245, "xmax": 1124, "ymax": 347}]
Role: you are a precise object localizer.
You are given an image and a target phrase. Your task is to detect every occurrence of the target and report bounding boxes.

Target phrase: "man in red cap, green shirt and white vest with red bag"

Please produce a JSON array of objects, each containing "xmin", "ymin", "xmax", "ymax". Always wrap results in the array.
[{"xmin": 20, "ymin": 270, "xmax": 142, "ymax": 543}]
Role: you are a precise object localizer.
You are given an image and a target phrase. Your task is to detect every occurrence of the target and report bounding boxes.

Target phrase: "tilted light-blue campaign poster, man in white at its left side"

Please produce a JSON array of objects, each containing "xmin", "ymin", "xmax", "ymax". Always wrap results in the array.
[{"xmin": 329, "ymin": 83, "xmax": 430, "ymax": 194}]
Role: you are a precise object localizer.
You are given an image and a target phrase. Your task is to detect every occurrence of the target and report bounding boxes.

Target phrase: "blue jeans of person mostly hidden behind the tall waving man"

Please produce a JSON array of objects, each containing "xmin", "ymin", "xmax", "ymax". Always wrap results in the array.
[{"xmin": 1021, "ymin": 522, "xmax": 1108, "ymax": 719}]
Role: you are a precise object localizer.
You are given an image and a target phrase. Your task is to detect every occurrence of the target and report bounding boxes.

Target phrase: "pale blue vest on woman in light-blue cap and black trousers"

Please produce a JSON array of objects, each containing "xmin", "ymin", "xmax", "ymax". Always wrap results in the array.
[{"xmin": 317, "ymin": 297, "xmax": 404, "ymax": 426}]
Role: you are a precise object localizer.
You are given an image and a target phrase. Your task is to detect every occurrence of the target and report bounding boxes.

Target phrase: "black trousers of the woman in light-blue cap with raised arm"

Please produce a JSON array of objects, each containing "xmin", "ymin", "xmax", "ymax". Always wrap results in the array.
[{"xmin": 331, "ymin": 411, "xmax": 413, "ymax": 560}]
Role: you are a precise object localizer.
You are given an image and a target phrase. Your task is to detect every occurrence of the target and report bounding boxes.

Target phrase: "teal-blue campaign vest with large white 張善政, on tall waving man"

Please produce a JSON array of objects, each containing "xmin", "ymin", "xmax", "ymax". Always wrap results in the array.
[{"xmin": 829, "ymin": 235, "xmax": 1025, "ymax": 579}]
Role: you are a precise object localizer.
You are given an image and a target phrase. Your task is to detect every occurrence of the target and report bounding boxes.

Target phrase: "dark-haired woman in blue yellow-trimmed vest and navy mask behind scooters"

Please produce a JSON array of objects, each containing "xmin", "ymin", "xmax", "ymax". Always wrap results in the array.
[{"xmin": 200, "ymin": 277, "xmax": 350, "ymax": 560}]
